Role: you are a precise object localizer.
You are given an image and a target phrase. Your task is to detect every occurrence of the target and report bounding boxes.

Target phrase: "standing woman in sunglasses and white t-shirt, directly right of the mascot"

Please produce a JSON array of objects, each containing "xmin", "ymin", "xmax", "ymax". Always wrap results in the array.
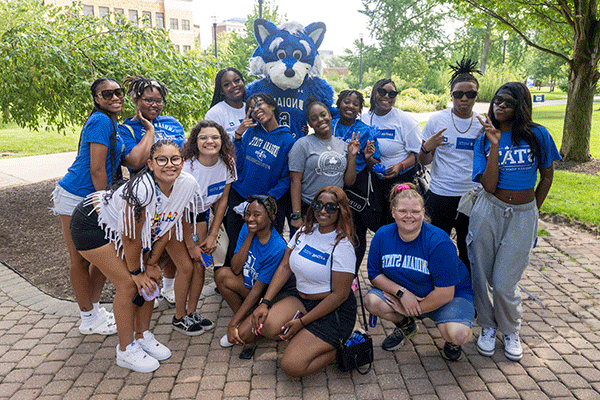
[{"xmin": 361, "ymin": 79, "xmax": 421, "ymax": 226}]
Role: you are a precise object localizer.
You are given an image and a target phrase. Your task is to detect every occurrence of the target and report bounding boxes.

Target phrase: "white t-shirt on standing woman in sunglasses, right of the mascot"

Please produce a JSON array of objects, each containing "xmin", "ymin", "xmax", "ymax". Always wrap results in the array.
[{"xmin": 360, "ymin": 108, "xmax": 421, "ymax": 167}]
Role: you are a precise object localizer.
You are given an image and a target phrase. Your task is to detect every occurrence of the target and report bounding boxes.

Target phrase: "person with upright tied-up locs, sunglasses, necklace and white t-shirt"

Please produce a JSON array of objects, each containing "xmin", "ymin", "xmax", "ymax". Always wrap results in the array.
[{"xmin": 419, "ymin": 57, "xmax": 483, "ymax": 270}]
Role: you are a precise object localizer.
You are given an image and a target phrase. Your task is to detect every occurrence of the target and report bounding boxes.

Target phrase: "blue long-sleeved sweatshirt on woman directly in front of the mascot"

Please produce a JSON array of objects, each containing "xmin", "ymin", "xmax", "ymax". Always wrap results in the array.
[{"xmin": 231, "ymin": 125, "xmax": 295, "ymax": 199}]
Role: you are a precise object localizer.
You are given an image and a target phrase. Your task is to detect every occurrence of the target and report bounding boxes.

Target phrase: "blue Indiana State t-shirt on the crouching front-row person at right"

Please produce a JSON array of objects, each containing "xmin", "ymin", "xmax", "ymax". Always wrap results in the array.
[{"xmin": 367, "ymin": 222, "xmax": 473, "ymax": 300}]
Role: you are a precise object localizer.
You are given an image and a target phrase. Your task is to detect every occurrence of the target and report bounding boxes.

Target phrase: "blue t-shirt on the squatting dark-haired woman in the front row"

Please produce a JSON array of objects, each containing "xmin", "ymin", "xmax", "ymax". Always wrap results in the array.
[{"xmin": 235, "ymin": 224, "xmax": 287, "ymax": 289}]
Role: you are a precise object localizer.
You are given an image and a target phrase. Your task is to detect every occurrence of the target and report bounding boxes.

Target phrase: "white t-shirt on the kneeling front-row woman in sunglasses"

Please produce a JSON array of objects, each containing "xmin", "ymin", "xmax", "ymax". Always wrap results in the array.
[{"xmin": 288, "ymin": 226, "xmax": 356, "ymax": 294}]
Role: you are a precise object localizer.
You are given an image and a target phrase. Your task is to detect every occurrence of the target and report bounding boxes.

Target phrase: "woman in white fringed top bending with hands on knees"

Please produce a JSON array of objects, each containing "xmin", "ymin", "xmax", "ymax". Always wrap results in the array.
[{"xmin": 71, "ymin": 140, "xmax": 198, "ymax": 372}]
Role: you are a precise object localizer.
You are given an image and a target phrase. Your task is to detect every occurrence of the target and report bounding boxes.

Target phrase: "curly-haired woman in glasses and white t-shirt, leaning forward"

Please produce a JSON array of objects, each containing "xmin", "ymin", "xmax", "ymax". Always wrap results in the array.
[{"xmin": 182, "ymin": 120, "xmax": 237, "ymax": 330}]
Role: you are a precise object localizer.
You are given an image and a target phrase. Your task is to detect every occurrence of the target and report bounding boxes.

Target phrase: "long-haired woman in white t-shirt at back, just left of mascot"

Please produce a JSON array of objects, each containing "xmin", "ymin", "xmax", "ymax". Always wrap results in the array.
[{"xmin": 204, "ymin": 67, "xmax": 246, "ymax": 141}]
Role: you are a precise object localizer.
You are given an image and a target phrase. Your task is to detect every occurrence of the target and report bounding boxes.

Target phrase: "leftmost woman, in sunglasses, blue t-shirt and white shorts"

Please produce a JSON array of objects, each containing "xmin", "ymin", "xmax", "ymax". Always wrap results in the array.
[{"xmin": 52, "ymin": 78, "xmax": 154, "ymax": 335}]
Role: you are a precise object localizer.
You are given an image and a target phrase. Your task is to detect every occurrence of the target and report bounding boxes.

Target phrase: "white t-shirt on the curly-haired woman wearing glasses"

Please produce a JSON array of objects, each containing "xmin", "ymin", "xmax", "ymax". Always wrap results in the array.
[{"xmin": 183, "ymin": 157, "xmax": 237, "ymax": 213}]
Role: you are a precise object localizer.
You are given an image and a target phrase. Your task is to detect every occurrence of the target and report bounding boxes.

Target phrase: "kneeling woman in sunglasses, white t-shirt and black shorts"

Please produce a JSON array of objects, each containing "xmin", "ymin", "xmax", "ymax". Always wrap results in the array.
[{"xmin": 252, "ymin": 186, "xmax": 356, "ymax": 376}]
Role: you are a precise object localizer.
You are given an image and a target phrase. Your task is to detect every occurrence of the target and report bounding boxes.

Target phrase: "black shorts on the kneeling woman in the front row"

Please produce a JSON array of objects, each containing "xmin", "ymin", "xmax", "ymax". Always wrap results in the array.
[{"xmin": 298, "ymin": 291, "xmax": 356, "ymax": 349}]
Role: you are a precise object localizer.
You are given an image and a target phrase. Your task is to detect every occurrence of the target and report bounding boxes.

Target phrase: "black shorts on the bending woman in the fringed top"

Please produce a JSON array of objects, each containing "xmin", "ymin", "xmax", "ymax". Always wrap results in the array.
[{"xmin": 70, "ymin": 200, "xmax": 110, "ymax": 251}]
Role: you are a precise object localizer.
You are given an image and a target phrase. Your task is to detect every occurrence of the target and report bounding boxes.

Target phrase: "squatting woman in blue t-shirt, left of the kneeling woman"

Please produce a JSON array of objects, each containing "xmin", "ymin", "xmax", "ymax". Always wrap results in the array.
[{"xmin": 215, "ymin": 195, "xmax": 286, "ymax": 359}]
